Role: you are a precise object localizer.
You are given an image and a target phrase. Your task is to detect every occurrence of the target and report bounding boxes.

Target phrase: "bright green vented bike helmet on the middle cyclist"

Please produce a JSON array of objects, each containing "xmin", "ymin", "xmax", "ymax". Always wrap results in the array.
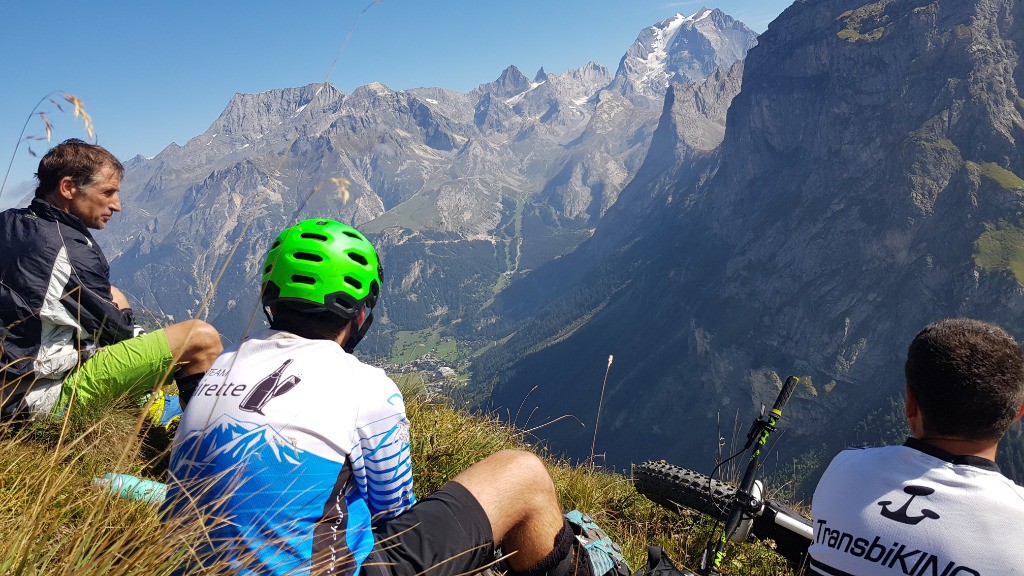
[{"xmin": 261, "ymin": 218, "xmax": 382, "ymax": 320}]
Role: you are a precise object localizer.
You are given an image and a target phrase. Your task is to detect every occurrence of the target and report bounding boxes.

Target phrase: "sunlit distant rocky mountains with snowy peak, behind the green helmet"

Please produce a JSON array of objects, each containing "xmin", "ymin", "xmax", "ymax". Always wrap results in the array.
[{"xmin": 102, "ymin": 11, "xmax": 755, "ymax": 356}]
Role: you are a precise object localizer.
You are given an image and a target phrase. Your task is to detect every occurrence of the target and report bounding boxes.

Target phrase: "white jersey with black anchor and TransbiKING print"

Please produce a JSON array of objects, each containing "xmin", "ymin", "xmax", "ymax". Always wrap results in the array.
[{"xmin": 810, "ymin": 438, "xmax": 1024, "ymax": 576}]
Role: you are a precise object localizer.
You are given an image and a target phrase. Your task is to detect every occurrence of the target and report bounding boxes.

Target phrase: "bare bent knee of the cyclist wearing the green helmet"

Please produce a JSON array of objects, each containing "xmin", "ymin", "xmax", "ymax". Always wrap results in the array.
[{"xmin": 453, "ymin": 450, "xmax": 564, "ymax": 572}]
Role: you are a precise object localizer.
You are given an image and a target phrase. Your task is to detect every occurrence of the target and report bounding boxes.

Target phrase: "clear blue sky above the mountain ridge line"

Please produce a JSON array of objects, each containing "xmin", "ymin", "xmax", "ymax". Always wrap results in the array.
[{"xmin": 0, "ymin": 0, "xmax": 792, "ymax": 206}]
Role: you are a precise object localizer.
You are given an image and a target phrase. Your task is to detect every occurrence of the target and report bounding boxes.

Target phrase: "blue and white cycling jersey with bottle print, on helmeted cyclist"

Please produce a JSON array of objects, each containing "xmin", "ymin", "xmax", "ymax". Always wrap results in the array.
[{"xmin": 169, "ymin": 331, "xmax": 416, "ymax": 575}]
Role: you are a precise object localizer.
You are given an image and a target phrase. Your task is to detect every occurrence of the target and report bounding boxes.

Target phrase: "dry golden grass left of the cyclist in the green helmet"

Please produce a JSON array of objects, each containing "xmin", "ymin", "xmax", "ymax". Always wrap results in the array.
[{"xmin": 0, "ymin": 411, "xmax": 203, "ymax": 575}]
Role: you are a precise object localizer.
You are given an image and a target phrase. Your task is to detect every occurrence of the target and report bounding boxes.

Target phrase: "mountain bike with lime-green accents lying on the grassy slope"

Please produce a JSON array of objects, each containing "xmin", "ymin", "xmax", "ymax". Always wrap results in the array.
[{"xmin": 633, "ymin": 376, "xmax": 813, "ymax": 576}]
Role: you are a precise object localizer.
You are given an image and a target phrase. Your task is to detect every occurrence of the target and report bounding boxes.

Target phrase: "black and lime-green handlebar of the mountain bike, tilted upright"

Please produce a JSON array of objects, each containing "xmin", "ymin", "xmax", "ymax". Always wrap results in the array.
[{"xmin": 701, "ymin": 376, "xmax": 800, "ymax": 576}]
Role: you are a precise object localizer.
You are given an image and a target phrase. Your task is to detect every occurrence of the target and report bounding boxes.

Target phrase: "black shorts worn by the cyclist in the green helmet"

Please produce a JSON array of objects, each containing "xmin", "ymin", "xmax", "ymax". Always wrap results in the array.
[{"xmin": 360, "ymin": 482, "xmax": 495, "ymax": 576}]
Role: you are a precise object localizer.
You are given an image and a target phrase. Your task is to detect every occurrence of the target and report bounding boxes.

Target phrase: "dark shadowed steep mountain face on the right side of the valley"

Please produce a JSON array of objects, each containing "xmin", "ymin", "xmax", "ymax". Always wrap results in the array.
[{"xmin": 483, "ymin": 0, "xmax": 1024, "ymax": 483}]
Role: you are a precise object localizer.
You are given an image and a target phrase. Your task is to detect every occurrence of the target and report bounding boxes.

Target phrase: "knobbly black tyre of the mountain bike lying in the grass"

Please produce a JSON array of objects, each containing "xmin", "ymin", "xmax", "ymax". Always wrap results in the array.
[{"xmin": 633, "ymin": 460, "xmax": 736, "ymax": 522}]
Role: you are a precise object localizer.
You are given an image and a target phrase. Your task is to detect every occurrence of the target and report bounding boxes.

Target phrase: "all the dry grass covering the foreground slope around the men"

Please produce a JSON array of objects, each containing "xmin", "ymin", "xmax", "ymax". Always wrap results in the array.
[{"xmin": 0, "ymin": 390, "xmax": 791, "ymax": 576}]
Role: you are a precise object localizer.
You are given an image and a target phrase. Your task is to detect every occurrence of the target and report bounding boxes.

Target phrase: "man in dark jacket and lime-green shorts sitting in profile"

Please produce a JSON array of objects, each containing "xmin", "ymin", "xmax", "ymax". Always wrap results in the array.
[{"xmin": 0, "ymin": 138, "xmax": 222, "ymax": 420}]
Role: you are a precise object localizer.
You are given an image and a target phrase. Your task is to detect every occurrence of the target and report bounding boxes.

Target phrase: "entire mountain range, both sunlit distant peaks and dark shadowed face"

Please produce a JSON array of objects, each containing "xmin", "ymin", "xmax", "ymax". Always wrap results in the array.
[{"xmin": 103, "ymin": 0, "xmax": 1024, "ymax": 487}]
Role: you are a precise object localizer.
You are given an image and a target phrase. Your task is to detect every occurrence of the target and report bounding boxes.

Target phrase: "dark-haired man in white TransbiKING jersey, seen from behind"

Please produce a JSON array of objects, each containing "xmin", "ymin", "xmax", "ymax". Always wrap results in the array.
[{"xmin": 810, "ymin": 319, "xmax": 1024, "ymax": 576}]
